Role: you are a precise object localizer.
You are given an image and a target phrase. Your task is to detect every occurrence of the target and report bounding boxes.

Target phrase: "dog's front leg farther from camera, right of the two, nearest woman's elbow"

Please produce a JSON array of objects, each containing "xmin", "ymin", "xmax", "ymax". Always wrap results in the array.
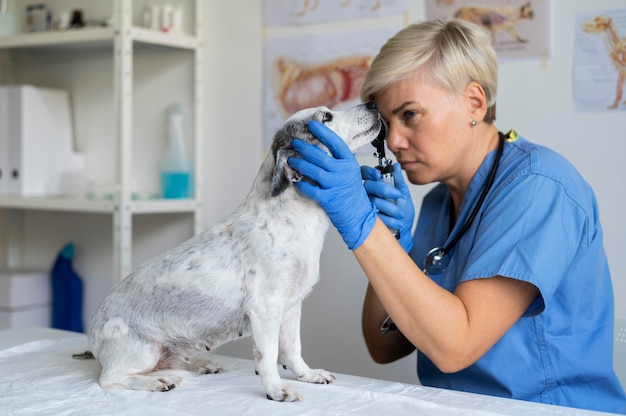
[{"xmin": 279, "ymin": 302, "xmax": 335, "ymax": 384}]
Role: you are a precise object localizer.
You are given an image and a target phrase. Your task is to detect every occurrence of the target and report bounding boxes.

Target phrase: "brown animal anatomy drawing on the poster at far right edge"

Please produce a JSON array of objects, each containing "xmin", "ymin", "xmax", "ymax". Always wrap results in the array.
[{"xmin": 583, "ymin": 16, "xmax": 626, "ymax": 109}]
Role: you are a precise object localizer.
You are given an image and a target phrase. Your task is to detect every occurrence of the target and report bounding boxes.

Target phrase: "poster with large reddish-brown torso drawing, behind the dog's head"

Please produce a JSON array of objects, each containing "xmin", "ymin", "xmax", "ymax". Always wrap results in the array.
[{"xmin": 263, "ymin": 27, "xmax": 400, "ymax": 149}]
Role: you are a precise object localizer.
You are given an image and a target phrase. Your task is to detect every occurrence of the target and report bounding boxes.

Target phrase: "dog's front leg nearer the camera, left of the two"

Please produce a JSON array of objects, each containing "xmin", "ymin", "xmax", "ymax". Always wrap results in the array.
[{"xmin": 249, "ymin": 306, "xmax": 302, "ymax": 402}]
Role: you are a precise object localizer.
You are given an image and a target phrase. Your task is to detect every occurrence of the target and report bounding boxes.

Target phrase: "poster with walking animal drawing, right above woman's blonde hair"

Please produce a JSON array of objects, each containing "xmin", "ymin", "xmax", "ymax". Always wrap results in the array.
[{"xmin": 426, "ymin": 0, "xmax": 550, "ymax": 59}]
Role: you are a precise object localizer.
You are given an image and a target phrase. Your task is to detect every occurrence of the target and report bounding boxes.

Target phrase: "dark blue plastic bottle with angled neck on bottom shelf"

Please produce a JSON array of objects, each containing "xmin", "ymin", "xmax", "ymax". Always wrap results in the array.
[{"xmin": 50, "ymin": 243, "xmax": 85, "ymax": 332}]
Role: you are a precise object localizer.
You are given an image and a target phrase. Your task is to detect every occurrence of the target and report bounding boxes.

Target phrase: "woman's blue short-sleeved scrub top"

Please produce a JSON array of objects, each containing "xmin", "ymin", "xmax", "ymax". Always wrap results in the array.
[{"xmin": 410, "ymin": 137, "xmax": 626, "ymax": 413}]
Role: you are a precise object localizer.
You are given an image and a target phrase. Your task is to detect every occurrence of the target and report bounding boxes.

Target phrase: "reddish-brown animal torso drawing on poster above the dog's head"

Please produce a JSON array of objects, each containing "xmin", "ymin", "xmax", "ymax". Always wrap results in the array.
[{"xmin": 274, "ymin": 55, "xmax": 372, "ymax": 116}]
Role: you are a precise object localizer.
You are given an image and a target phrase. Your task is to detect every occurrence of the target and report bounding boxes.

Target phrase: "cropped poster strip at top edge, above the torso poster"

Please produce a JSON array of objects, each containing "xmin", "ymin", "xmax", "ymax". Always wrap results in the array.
[{"xmin": 263, "ymin": 0, "xmax": 407, "ymax": 25}]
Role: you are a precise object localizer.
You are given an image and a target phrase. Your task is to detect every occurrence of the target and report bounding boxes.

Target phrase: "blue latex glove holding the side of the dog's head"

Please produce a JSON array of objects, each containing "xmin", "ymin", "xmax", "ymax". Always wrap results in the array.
[{"xmin": 287, "ymin": 121, "xmax": 378, "ymax": 250}]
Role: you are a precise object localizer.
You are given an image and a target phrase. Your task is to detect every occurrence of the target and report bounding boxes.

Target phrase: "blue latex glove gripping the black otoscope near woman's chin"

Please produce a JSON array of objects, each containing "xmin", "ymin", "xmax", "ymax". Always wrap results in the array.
[{"xmin": 361, "ymin": 163, "xmax": 415, "ymax": 253}]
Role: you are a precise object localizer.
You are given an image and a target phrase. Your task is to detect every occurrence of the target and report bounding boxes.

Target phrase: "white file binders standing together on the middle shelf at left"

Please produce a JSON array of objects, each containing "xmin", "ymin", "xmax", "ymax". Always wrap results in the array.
[{"xmin": 0, "ymin": 85, "xmax": 85, "ymax": 196}]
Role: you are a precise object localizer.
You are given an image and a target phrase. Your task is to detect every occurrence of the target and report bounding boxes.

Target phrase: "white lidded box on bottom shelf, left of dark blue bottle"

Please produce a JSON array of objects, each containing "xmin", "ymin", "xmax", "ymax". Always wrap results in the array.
[{"xmin": 0, "ymin": 270, "xmax": 52, "ymax": 329}]
